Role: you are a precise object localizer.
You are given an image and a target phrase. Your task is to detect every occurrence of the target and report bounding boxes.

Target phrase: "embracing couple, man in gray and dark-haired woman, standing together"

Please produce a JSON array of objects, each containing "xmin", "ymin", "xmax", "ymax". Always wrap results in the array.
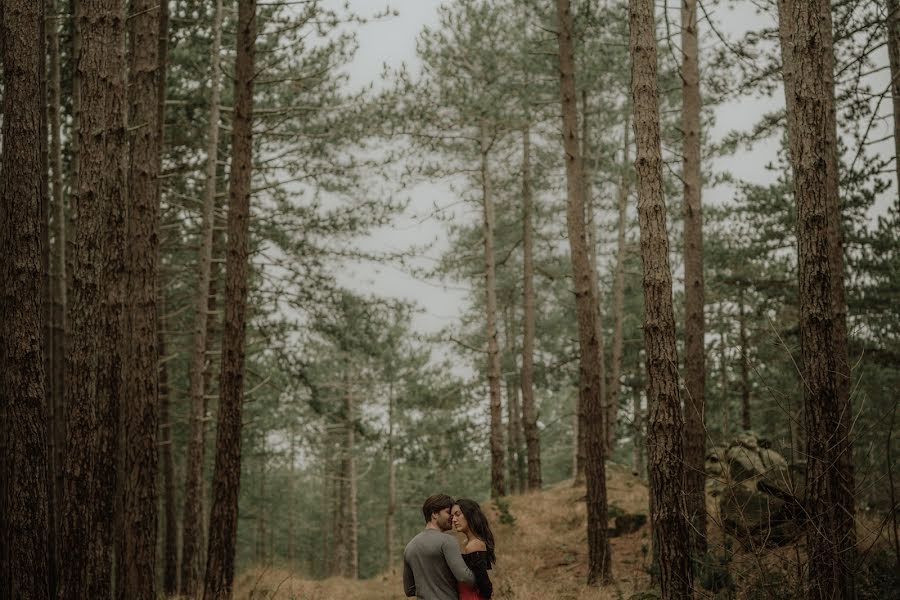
[{"xmin": 403, "ymin": 494, "xmax": 496, "ymax": 600}]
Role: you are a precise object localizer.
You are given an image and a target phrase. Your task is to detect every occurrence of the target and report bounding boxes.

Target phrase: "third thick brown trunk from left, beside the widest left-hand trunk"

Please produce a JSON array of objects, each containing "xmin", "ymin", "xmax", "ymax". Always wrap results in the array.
[{"xmin": 116, "ymin": 0, "xmax": 160, "ymax": 600}]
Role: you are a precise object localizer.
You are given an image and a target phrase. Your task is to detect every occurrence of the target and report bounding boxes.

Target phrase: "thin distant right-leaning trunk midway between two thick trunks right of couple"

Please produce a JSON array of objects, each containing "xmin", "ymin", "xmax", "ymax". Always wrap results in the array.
[{"xmin": 607, "ymin": 110, "xmax": 631, "ymax": 460}]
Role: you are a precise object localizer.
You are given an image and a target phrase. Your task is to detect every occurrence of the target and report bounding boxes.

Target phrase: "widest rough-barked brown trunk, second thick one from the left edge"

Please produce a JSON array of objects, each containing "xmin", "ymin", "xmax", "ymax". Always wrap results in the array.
[{"xmin": 58, "ymin": 0, "xmax": 128, "ymax": 600}]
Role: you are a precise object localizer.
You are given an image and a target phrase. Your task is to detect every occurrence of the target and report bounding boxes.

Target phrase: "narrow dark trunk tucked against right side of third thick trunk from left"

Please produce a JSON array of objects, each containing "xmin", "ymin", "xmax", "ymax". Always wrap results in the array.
[{"xmin": 156, "ymin": 0, "xmax": 178, "ymax": 597}]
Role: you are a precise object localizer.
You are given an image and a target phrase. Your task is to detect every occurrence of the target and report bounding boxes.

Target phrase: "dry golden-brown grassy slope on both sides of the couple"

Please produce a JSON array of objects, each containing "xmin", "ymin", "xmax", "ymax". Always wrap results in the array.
[{"xmin": 235, "ymin": 464, "xmax": 650, "ymax": 600}]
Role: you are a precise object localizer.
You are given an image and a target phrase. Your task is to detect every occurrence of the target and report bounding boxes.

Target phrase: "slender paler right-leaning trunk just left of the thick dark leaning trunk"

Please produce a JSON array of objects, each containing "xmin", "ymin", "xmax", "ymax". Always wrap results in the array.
[{"xmin": 181, "ymin": 0, "xmax": 223, "ymax": 596}]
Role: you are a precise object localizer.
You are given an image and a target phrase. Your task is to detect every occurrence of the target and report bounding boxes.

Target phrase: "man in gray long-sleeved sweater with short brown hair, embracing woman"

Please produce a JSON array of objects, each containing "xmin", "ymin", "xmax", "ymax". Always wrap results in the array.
[{"xmin": 403, "ymin": 494, "xmax": 475, "ymax": 600}]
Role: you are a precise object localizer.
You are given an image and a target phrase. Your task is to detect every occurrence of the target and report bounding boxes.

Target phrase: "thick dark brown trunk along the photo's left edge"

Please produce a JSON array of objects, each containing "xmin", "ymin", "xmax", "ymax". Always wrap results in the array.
[{"xmin": 0, "ymin": 0, "xmax": 51, "ymax": 598}]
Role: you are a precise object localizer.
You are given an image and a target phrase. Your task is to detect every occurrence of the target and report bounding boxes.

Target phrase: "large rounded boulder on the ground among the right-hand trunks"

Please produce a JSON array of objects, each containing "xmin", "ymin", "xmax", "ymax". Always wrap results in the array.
[{"xmin": 706, "ymin": 432, "xmax": 804, "ymax": 547}]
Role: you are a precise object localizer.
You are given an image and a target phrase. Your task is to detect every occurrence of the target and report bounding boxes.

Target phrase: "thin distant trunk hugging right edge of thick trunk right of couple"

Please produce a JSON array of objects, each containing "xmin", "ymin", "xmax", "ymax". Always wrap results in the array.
[{"xmin": 581, "ymin": 90, "xmax": 616, "ymax": 456}]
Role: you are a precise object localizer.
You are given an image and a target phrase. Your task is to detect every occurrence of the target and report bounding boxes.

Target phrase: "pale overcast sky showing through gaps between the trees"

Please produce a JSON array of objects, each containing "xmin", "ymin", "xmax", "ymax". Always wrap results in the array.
[{"xmin": 320, "ymin": 0, "xmax": 889, "ymax": 342}]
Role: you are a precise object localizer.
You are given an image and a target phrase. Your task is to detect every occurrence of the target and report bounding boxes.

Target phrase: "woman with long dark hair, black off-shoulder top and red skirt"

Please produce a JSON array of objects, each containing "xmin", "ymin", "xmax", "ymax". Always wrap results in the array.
[{"xmin": 450, "ymin": 498, "xmax": 497, "ymax": 600}]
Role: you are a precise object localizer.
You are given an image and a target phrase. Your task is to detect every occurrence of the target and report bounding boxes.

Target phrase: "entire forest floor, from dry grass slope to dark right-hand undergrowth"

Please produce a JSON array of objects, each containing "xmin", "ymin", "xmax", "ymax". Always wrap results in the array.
[{"xmin": 235, "ymin": 463, "xmax": 900, "ymax": 600}]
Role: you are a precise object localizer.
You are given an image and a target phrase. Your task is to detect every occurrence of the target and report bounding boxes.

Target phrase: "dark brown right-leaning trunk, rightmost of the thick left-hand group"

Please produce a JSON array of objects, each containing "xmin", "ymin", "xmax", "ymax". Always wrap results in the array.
[{"xmin": 203, "ymin": 0, "xmax": 256, "ymax": 600}]
